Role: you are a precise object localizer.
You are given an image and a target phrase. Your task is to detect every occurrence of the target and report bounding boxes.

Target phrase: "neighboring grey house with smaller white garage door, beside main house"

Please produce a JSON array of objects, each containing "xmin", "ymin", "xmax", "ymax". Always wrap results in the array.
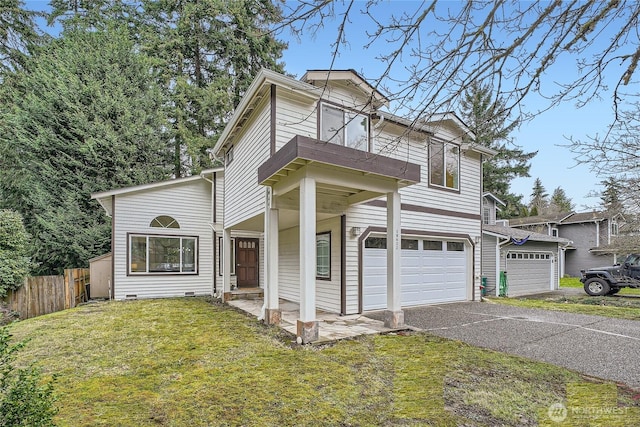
[{"xmin": 482, "ymin": 193, "xmax": 570, "ymax": 296}]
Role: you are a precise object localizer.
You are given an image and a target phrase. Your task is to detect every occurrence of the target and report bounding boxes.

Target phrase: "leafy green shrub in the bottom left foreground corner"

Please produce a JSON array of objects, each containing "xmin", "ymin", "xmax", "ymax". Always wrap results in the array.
[{"xmin": 0, "ymin": 326, "xmax": 57, "ymax": 427}]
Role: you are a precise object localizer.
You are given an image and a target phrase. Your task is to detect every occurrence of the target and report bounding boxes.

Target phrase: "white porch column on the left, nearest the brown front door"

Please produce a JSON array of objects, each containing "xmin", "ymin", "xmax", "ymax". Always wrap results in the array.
[{"xmin": 264, "ymin": 188, "xmax": 282, "ymax": 325}]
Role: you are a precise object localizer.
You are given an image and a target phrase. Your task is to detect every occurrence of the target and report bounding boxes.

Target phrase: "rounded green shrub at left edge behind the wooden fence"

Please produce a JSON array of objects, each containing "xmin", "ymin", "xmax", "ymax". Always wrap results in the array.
[{"xmin": 0, "ymin": 209, "xmax": 31, "ymax": 298}]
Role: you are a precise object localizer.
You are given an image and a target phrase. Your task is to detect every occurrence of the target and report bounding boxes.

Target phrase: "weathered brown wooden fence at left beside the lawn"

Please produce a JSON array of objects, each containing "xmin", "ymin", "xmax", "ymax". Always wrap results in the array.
[{"xmin": 5, "ymin": 268, "xmax": 89, "ymax": 319}]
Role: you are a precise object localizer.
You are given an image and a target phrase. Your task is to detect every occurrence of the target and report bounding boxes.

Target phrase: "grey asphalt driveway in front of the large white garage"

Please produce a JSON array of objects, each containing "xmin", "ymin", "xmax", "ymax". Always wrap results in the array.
[{"xmin": 373, "ymin": 302, "xmax": 640, "ymax": 390}]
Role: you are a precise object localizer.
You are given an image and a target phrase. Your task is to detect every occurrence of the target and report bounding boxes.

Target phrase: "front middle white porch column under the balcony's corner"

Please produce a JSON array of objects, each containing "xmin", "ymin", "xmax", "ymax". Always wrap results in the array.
[{"xmin": 297, "ymin": 177, "xmax": 318, "ymax": 343}]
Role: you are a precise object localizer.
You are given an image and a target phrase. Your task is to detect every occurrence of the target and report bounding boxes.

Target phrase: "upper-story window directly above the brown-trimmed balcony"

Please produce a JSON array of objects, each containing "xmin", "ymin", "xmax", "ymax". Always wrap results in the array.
[{"xmin": 320, "ymin": 104, "xmax": 369, "ymax": 151}]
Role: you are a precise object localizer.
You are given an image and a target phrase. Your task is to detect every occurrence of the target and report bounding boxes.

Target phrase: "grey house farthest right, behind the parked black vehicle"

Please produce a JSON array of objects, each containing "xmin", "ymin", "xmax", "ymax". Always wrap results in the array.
[{"xmin": 509, "ymin": 211, "xmax": 623, "ymax": 277}]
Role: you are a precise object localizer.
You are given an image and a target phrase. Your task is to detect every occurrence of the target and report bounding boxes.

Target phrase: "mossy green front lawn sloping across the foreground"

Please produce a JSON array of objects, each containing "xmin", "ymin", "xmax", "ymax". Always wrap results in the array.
[{"xmin": 12, "ymin": 298, "xmax": 640, "ymax": 427}]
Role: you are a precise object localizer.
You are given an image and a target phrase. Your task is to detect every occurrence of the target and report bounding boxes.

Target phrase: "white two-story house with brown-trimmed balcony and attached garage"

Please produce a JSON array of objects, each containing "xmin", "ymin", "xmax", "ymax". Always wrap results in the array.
[{"xmin": 93, "ymin": 70, "xmax": 496, "ymax": 342}]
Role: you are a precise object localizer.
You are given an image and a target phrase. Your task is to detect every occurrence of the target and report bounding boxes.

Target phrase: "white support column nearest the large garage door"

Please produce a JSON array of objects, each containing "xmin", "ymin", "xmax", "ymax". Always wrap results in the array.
[{"xmin": 384, "ymin": 189, "xmax": 404, "ymax": 328}]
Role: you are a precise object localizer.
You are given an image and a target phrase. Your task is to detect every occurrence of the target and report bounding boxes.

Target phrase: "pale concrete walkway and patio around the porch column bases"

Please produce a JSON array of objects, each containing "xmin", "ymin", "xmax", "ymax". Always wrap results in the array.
[{"xmin": 228, "ymin": 300, "xmax": 393, "ymax": 343}]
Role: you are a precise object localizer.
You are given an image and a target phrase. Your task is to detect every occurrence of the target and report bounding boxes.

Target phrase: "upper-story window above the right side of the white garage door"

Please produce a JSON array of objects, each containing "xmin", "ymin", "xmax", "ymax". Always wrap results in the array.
[{"xmin": 429, "ymin": 141, "xmax": 460, "ymax": 190}]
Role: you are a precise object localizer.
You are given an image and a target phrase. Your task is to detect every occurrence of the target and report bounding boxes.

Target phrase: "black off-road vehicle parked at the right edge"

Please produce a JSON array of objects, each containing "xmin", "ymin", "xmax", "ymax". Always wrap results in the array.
[{"xmin": 580, "ymin": 254, "xmax": 640, "ymax": 296}]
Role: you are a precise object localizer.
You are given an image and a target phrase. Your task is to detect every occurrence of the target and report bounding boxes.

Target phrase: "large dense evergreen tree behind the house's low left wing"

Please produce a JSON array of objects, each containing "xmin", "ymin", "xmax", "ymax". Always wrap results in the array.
[{"xmin": 0, "ymin": 29, "xmax": 170, "ymax": 274}]
